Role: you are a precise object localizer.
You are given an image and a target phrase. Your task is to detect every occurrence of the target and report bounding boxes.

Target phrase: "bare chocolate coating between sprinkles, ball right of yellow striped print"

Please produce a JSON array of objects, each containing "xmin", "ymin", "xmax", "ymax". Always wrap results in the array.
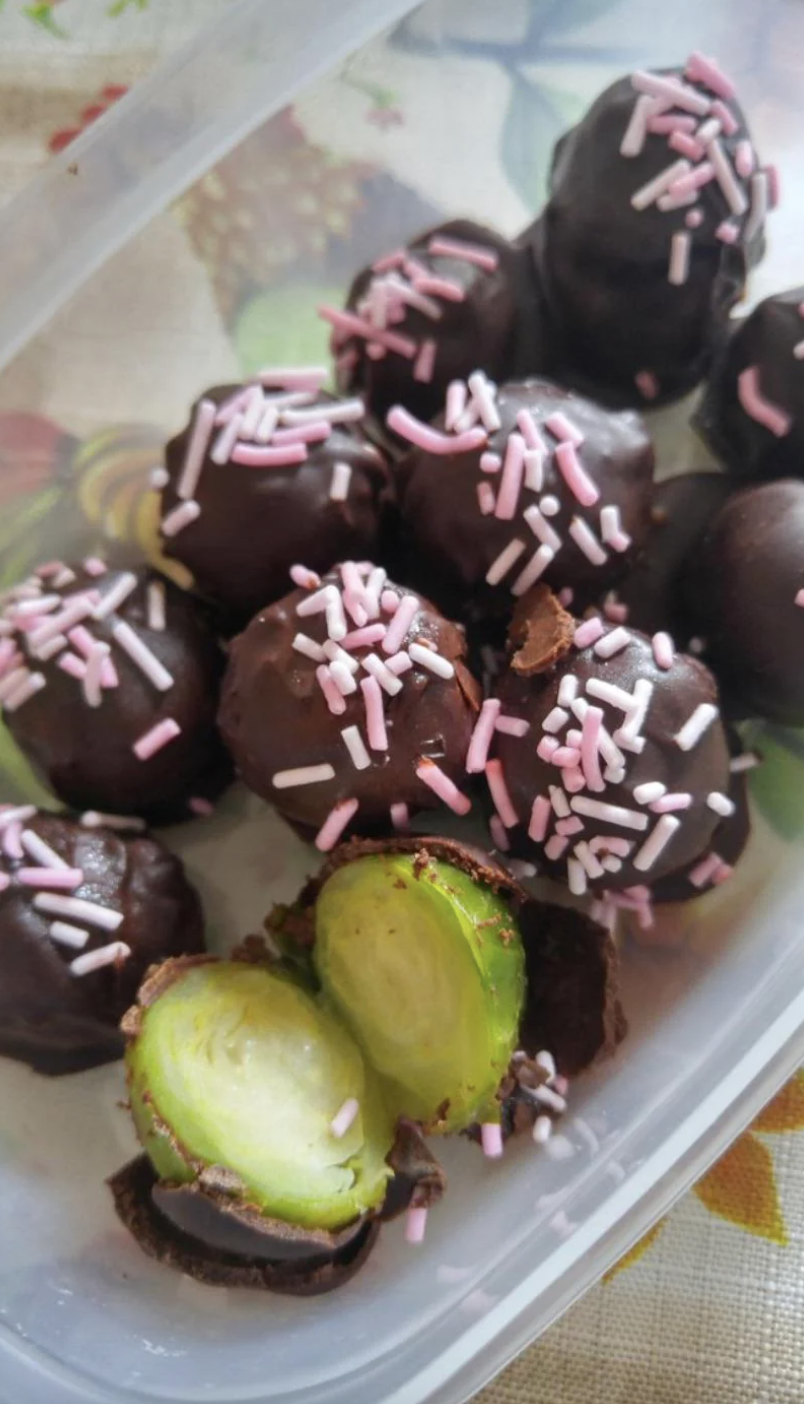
[{"xmin": 161, "ymin": 385, "xmax": 390, "ymax": 628}]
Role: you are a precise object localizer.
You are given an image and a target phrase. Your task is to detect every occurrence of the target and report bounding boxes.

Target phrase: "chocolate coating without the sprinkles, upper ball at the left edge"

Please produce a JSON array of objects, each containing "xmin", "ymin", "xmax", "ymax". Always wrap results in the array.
[{"xmin": 3, "ymin": 566, "xmax": 232, "ymax": 823}]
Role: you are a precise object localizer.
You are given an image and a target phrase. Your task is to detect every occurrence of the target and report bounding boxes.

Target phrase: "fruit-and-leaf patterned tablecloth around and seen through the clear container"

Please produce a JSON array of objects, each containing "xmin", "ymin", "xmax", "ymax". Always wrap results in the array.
[{"xmin": 0, "ymin": 0, "xmax": 804, "ymax": 1404}]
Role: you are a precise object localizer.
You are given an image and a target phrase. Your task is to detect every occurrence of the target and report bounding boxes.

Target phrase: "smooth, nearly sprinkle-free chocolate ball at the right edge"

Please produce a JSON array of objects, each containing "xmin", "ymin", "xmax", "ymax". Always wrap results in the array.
[{"xmin": 685, "ymin": 479, "xmax": 804, "ymax": 726}]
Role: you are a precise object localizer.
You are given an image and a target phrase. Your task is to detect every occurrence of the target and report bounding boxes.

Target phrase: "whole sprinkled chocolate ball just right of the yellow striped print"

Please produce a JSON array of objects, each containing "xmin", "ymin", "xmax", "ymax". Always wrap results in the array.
[{"xmin": 161, "ymin": 368, "xmax": 390, "ymax": 628}]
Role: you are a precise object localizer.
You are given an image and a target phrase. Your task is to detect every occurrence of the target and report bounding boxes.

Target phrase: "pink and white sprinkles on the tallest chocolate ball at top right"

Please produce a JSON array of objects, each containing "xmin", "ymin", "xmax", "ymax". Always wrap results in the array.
[{"xmin": 620, "ymin": 53, "xmax": 779, "ymax": 400}]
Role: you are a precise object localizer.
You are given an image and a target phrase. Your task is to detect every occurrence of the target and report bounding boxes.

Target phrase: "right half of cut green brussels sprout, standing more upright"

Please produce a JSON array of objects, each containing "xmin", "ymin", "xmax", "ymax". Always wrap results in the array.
[{"xmin": 313, "ymin": 854, "xmax": 525, "ymax": 1130}]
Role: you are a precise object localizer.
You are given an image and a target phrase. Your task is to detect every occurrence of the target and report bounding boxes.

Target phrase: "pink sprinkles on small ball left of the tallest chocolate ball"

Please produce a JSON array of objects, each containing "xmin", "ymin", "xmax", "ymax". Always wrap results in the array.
[{"xmin": 319, "ymin": 234, "xmax": 500, "ymax": 385}]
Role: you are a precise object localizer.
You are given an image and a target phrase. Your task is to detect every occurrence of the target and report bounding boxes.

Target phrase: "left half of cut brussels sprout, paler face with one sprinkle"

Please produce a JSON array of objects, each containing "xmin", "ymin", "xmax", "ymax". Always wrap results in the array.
[{"xmin": 126, "ymin": 962, "xmax": 394, "ymax": 1229}]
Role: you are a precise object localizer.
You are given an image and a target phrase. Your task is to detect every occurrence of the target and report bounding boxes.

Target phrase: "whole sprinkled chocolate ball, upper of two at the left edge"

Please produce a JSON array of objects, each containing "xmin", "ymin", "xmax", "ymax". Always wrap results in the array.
[{"xmin": 0, "ymin": 557, "xmax": 232, "ymax": 823}]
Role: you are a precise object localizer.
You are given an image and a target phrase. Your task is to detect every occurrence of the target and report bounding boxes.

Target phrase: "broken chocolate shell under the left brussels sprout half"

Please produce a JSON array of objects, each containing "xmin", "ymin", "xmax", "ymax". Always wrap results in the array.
[{"xmin": 108, "ymin": 1155, "xmax": 380, "ymax": 1297}]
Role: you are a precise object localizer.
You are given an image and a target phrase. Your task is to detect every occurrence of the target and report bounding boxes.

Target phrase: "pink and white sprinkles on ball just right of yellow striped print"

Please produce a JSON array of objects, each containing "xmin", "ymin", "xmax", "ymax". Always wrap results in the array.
[{"xmin": 159, "ymin": 366, "xmax": 365, "ymax": 536}]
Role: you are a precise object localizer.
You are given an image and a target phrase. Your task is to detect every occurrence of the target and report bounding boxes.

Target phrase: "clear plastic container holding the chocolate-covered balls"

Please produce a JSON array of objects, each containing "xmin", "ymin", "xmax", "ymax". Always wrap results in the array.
[{"xmin": 0, "ymin": 0, "xmax": 804, "ymax": 1404}]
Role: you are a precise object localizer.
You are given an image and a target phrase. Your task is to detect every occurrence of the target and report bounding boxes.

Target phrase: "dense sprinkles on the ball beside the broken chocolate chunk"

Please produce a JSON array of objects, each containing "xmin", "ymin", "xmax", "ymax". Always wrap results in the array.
[{"xmin": 466, "ymin": 618, "xmax": 734, "ymax": 922}]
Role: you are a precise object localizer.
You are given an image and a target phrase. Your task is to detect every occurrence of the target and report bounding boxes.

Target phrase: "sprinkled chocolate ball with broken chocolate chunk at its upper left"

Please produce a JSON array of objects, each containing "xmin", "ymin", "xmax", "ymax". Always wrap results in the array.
[{"xmin": 485, "ymin": 600, "xmax": 731, "ymax": 894}]
